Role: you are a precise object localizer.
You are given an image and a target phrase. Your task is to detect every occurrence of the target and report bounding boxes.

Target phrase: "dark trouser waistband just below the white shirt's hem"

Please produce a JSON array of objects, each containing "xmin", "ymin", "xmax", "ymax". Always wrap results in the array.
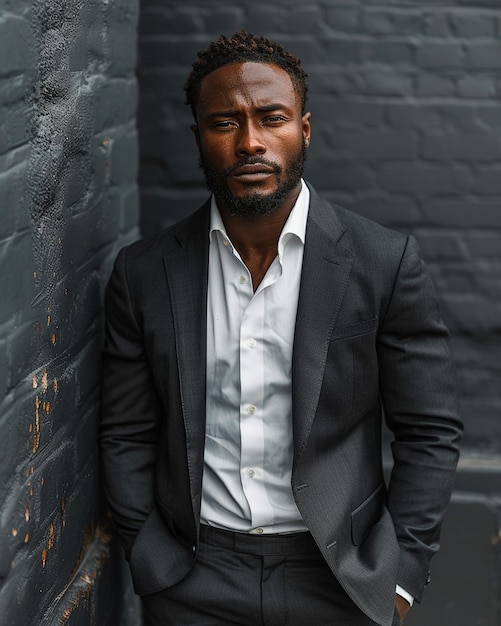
[{"xmin": 200, "ymin": 524, "xmax": 318, "ymax": 556}]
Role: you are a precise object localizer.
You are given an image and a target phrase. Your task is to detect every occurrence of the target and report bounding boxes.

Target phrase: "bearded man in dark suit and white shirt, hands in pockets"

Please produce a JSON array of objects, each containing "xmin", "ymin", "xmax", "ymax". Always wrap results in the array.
[{"xmin": 101, "ymin": 32, "xmax": 461, "ymax": 626}]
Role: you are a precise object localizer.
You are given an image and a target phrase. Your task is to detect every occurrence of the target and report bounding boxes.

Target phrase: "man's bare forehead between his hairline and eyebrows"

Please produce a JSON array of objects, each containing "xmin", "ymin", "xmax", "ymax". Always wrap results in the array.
[{"xmin": 199, "ymin": 62, "xmax": 300, "ymax": 110}]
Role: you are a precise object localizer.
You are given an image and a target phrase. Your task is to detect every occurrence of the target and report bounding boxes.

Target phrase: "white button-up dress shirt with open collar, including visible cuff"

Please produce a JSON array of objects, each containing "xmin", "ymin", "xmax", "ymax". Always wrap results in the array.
[{"xmin": 201, "ymin": 181, "xmax": 413, "ymax": 604}]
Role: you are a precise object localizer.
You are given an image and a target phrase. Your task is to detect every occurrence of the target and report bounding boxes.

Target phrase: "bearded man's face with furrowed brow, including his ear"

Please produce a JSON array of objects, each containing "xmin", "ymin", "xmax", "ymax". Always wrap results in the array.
[{"xmin": 193, "ymin": 63, "xmax": 310, "ymax": 216}]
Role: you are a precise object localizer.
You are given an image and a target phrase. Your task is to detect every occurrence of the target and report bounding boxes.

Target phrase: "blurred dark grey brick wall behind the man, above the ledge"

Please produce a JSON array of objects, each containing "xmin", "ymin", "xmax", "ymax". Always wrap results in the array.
[{"xmin": 139, "ymin": 0, "xmax": 501, "ymax": 458}]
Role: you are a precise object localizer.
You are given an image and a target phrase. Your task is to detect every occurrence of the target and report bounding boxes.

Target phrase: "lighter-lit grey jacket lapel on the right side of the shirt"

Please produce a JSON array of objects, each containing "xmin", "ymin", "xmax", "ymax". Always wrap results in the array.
[{"xmin": 292, "ymin": 188, "xmax": 353, "ymax": 463}]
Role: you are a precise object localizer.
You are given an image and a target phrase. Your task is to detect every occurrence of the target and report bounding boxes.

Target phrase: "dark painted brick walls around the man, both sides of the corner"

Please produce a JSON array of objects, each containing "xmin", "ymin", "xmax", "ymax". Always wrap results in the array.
[{"xmin": 0, "ymin": 0, "xmax": 501, "ymax": 626}]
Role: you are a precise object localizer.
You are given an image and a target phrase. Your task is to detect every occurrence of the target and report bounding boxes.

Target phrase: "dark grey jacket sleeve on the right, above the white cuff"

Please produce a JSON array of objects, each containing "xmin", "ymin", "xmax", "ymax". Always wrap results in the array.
[{"xmin": 378, "ymin": 237, "xmax": 462, "ymax": 601}]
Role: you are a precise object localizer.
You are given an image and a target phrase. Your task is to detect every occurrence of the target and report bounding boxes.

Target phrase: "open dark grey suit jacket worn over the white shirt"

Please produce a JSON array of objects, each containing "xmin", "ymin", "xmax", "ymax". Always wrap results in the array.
[{"xmin": 101, "ymin": 185, "xmax": 461, "ymax": 625}]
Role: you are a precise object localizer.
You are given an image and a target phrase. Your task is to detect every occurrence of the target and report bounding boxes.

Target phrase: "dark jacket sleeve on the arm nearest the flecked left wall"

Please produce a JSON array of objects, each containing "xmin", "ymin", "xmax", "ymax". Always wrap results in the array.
[{"xmin": 100, "ymin": 244, "xmax": 160, "ymax": 558}]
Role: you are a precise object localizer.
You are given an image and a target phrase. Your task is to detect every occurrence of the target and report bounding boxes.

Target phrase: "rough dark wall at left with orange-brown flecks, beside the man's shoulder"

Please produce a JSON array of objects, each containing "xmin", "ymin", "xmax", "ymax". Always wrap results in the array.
[{"xmin": 0, "ymin": 0, "xmax": 139, "ymax": 626}]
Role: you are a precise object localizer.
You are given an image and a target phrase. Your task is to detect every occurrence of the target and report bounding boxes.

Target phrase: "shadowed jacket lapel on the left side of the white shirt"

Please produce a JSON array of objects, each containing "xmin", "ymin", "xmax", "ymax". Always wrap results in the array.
[{"xmin": 164, "ymin": 204, "xmax": 209, "ymax": 512}]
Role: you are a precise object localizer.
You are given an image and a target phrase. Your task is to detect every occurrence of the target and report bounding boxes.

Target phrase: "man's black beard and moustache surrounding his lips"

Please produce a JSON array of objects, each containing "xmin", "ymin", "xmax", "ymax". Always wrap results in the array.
[{"xmin": 199, "ymin": 142, "xmax": 307, "ymax": 217}]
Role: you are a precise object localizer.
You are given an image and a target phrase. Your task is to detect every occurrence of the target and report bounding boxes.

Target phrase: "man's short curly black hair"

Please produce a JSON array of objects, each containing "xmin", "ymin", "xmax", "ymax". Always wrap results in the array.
[{"xmin": 184, "ymin": 30, "xmax": 308, "ymax": 118}]
